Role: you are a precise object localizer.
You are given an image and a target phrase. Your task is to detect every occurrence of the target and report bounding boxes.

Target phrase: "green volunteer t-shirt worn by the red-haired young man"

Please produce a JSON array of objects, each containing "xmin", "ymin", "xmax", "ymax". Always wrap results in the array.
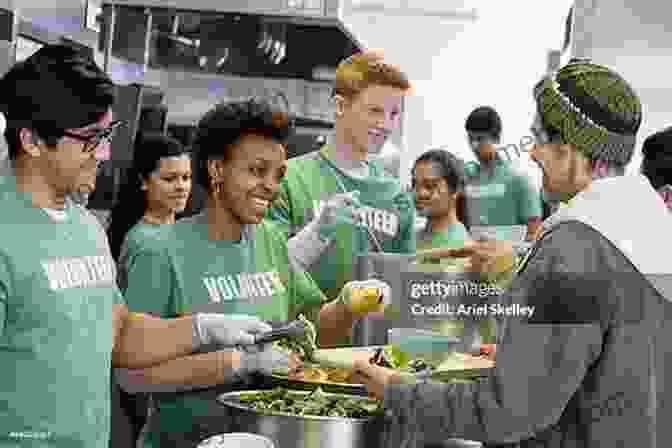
[{"xmin": 268, "ymin": 145, "xmax": 416, "ymax": 300}]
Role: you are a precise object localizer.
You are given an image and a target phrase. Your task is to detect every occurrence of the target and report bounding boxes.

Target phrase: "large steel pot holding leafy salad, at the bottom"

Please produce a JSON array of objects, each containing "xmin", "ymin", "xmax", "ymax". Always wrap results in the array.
[{"xmin": 217, "ymin": 391, "xmax": 385, "ymax": 448}]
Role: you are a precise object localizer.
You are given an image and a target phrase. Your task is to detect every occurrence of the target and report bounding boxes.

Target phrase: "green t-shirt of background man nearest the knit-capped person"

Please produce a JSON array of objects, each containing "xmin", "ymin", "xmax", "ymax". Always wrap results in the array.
[{"xmin": 465, "ymin": 160, "xmax": 542, "ymax": 231}]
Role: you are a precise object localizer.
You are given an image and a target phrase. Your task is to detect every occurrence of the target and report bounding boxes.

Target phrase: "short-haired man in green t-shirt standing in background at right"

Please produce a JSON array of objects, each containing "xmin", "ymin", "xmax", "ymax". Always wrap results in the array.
[{"xmin": 465, "ymin": 106, "xmax": 543, "ymax": 243}]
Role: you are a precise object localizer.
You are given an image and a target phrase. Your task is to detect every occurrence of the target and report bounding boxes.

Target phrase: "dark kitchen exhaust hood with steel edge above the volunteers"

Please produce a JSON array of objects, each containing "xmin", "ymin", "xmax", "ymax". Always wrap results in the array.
[{"xmin": 99, "ymin": 0, "xmax": 362, "ymax": 82}]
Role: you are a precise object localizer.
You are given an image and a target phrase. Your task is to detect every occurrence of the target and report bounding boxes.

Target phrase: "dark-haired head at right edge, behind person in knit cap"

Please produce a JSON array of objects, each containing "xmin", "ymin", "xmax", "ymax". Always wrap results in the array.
[{"xmin": 641, "ymin": 127, "xmax": 672, "ymax": 210}]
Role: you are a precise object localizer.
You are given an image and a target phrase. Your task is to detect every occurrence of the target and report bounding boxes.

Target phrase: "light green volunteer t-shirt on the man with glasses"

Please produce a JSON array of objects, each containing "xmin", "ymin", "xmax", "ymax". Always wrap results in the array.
[{"xmin": 0, "ymin": 183, "xmax": 123, "ymax": 448}]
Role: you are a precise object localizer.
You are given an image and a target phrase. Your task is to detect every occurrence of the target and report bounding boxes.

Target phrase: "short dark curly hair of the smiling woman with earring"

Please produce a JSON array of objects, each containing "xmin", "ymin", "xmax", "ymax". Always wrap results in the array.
[{"xmin": 192, "ymin": 98, "xmax": 293, "ymax": 191}]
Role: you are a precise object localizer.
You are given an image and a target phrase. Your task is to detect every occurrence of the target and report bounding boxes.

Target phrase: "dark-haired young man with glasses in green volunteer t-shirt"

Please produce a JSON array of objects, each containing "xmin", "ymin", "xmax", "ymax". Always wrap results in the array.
[{"xmin": 0, "ymin": 45, "xmax": 278, "ymax": 448}]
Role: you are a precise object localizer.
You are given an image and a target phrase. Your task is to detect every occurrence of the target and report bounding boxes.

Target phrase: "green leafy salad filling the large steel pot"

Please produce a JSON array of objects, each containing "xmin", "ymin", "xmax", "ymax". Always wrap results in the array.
[{"xmin": 240, "ymin": 387, "xmax": 383, "ymax": 418}]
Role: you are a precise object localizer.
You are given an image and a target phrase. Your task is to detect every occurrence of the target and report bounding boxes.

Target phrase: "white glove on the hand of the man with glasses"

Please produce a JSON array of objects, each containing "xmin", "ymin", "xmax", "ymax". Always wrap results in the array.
[{"xmin": 194, "ymin": 313, "xmax": 273, "ymax": 351}]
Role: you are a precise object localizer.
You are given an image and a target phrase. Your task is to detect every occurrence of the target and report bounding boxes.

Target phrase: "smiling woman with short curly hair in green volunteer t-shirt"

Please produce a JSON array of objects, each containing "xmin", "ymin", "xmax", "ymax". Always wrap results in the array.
[{"xmin": 119, "ymin": 99, "xmax": 389, "ymax": 448}]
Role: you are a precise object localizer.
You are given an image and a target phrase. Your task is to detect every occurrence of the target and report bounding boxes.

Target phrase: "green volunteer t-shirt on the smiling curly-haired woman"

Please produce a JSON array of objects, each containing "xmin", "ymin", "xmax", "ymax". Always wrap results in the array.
[{"xmin": 125, "ymin": 212, "xmax": 324, "ymax": 446}]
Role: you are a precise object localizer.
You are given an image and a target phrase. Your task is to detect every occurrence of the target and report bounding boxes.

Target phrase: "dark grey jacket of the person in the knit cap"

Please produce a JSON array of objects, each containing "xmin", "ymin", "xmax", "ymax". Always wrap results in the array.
[{"xmin": 385, "ymin": 221, "xmax": 672, "ymax": 448}]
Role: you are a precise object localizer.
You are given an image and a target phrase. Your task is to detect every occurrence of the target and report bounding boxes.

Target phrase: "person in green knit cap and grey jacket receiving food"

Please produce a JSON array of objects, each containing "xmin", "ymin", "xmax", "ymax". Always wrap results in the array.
[{"xmin": 356, "ymin": 61, "xmax": 672, "ymax": 448}]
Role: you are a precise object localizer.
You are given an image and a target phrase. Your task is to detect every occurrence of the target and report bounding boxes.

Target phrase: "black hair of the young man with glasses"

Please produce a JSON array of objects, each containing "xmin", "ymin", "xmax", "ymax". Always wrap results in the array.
[{"xmin": 0, "ymin": 45, "xmax": 116, "ymax": 159}]
